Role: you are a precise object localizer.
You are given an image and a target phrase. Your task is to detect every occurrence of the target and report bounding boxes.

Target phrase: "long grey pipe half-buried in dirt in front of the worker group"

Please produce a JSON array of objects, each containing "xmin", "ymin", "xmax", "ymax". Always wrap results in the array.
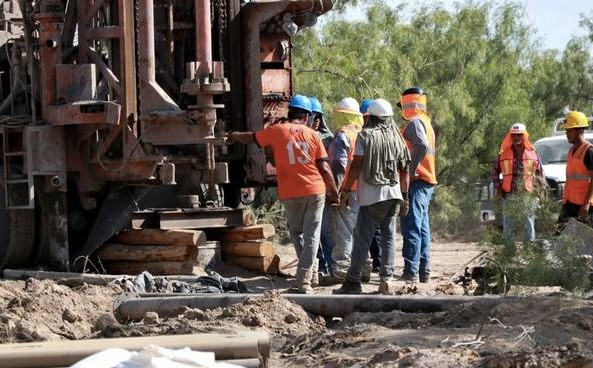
[{"xmin": 114, "ymin": 294, "xmax": 518, "ymax": 322}]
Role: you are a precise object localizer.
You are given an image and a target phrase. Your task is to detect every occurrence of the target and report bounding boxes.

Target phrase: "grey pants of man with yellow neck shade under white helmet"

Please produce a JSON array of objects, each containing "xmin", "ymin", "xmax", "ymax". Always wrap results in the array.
[{"xmin": 330, "ymin": 192, "xmax": 359, "ymax": 279}]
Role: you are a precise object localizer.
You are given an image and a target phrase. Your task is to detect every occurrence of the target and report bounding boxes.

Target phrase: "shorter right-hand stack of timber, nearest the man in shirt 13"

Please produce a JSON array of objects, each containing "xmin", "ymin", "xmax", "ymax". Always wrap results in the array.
[{"xmin": 208, "ymin": 224, "xmax": 280, "ymax": 273}]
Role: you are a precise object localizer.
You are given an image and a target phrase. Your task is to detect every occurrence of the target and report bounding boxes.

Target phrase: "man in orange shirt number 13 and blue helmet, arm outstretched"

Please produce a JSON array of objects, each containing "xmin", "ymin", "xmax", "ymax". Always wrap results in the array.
[{"xmin": 228, "ymin": 95, "xmax": 339, "ymax": 294}]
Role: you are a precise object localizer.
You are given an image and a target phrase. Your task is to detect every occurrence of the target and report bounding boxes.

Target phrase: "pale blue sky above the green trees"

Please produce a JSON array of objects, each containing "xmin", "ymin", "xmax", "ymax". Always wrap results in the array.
[{"xmin": 346, "ymin": 0, "xmax": 593, "ymax": 50}]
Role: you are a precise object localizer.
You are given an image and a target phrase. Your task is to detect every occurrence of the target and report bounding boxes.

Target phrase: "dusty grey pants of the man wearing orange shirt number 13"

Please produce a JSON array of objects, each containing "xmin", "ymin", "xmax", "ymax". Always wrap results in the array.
[{"xmin": 282, "ymin": 195, "xmax": 325, "ymax": 286}]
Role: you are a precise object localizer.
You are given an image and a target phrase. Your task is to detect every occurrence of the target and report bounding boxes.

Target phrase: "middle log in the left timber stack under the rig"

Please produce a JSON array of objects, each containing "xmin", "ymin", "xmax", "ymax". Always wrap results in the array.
[{"xmin": 96, "ymin": 243, "xmax": 196, "ymax": 262}]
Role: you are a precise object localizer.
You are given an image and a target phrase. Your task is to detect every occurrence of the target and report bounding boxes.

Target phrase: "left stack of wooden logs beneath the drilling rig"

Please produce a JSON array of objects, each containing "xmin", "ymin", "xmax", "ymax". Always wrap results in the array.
[{"xmin": 96, "ymin": 229, "xmax": 206, "ymax": 275}]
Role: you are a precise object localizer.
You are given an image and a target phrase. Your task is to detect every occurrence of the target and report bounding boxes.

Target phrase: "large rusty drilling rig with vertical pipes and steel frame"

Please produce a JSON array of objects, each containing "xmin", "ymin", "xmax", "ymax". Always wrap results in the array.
[{"xmin": 0, "ymin": 0, "xmax": 332, "ymax": 270}]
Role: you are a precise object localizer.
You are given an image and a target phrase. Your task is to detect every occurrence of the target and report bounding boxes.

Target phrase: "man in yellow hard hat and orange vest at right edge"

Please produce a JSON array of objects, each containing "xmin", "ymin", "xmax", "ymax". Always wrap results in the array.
[{"xmin": 558, "ymin": 111, "xmax": 593, "ymax": 223}]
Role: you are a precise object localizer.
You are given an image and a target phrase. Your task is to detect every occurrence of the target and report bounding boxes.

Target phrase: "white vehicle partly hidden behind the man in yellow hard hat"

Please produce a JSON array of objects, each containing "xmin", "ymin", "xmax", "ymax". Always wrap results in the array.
[{"xmin": 534, "ymin": 117, "xmax": 593, "ymax": 201}]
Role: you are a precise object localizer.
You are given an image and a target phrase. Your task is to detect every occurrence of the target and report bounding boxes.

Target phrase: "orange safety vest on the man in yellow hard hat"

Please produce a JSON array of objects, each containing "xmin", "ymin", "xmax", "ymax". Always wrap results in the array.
[{"xmin": 563, "ymin": 142, "xmax": 593, "ymax": 206}]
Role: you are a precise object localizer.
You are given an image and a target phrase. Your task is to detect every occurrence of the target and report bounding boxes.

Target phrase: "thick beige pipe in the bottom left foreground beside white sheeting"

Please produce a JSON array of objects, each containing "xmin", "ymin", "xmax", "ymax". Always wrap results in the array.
[{"xmin": 0, "ymin": 332, "xmax": 271, "ymax": 368}]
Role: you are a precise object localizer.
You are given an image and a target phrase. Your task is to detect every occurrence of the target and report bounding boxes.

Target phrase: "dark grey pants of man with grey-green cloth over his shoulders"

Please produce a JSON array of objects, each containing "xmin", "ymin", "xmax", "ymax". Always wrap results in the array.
[{"xmin": 346, "ymin": 199, "xmax": 400, "ymax": 283}]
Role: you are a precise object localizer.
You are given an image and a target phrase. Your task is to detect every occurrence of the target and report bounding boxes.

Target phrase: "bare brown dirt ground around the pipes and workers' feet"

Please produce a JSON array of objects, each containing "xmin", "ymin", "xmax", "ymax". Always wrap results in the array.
[{"xmin": 0, "ymin": 234, "xmax": 593, "ymax": 368}]
